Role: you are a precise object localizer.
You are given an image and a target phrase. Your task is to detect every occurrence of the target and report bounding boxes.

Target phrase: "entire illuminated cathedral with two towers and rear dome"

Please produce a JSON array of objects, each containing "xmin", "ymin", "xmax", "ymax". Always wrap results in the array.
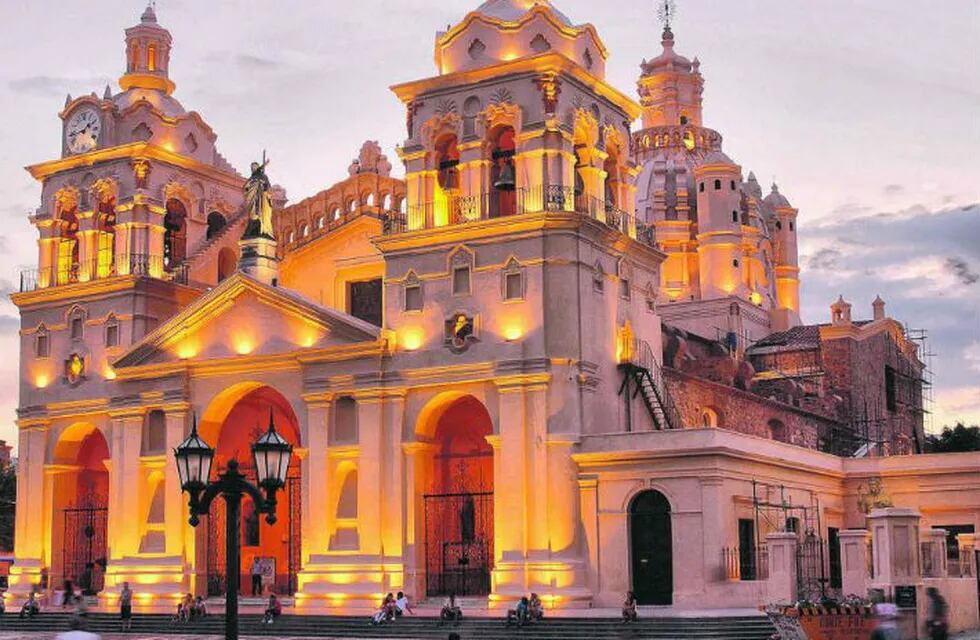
[{"xmin": 7, "ymin": 0, "xmax": 980, "ymax": 617}]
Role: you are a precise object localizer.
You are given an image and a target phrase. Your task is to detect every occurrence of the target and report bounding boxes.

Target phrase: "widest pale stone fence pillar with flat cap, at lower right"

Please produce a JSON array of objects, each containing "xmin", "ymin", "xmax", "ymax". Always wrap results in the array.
[{"xmin": 871, "ymin": 507, "xmax": 922, "ymax": 594}]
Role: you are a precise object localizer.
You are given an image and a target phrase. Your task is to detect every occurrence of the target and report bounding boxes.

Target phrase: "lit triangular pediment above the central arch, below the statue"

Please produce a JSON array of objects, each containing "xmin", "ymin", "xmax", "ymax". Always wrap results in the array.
[{"xmin": 113, "ymin": 273, "xmax": 381, "ymax": 369}]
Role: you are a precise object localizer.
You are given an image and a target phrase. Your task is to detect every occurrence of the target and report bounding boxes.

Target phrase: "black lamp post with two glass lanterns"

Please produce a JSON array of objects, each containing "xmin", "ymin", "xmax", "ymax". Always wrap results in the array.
[{"xmin": 174, "ymin": 409, "xmax": 293, "ymax": 640}]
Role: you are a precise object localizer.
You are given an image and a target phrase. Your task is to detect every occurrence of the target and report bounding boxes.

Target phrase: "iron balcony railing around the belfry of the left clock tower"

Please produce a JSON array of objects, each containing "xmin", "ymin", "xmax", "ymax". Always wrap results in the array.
[{"xmin": 20, "ymin": 253, "xmax": 188, "ymax": 293}]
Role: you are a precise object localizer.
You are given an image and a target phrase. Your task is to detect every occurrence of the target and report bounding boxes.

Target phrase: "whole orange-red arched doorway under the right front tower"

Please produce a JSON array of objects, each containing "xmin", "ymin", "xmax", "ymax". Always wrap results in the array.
[{"xmin": 423, "ymin": 395, "xmax": 493, "ymax": 596}]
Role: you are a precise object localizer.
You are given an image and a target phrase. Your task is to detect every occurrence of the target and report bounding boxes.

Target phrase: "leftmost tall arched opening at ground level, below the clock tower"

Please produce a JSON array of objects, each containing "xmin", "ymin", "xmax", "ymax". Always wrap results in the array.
[{"xmin": 51, "ymin": 422, "xmax": 109, "ymax": 594}]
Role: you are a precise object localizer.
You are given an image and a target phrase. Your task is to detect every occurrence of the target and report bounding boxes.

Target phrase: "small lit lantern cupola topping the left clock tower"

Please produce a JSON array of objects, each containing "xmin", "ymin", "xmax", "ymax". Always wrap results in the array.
[{"xmin": 119, "ymin": 2, "xmax": 175, "ymax": 96}]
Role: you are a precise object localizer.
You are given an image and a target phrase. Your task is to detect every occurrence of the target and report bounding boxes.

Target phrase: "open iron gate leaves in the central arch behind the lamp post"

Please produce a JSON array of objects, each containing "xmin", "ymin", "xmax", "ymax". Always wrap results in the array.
[{"xmin": 207, "ymin": 468, "xmax": 302, "ymax": 596}]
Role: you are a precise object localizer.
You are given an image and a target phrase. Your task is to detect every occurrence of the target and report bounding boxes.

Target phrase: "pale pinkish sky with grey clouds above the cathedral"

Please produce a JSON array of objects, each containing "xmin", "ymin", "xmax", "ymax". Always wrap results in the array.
[{"xmin": 0, "ymin": 0, "xmax": 980, "ymax": 450}]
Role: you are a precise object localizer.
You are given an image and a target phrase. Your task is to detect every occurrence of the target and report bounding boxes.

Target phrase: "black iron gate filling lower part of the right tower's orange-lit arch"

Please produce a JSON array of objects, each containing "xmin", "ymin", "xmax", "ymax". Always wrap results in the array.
[{"xmin": 424, "ymin": 492, "xmax": 493, "ymax": 596}]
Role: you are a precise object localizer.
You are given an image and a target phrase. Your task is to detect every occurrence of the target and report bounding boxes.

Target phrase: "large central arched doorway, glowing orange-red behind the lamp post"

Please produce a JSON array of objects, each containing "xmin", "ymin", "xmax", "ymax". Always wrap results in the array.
[{"xmin": 196, "ymin": 383, "xmax": 301, "ymax": 595}]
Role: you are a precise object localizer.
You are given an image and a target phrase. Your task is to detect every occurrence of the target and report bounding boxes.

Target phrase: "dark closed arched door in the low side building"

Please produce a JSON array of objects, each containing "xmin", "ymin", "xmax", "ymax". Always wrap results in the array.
[{"xmin": 629, "ymin": 490, "xmax": 674, "ymax": 604}]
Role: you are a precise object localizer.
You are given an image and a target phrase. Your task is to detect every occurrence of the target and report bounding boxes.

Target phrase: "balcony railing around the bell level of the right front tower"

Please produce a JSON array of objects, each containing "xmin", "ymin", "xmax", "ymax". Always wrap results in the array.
[{"xmin": 381, "ymin": 185, "xmax": 653, "ymax": 244}]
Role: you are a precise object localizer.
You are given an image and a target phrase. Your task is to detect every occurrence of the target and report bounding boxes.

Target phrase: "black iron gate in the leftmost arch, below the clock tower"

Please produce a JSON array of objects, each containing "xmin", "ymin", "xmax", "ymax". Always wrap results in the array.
[{"xmin": 62, "ymin": 494, "xmax": 109, "ymax": 595}]
